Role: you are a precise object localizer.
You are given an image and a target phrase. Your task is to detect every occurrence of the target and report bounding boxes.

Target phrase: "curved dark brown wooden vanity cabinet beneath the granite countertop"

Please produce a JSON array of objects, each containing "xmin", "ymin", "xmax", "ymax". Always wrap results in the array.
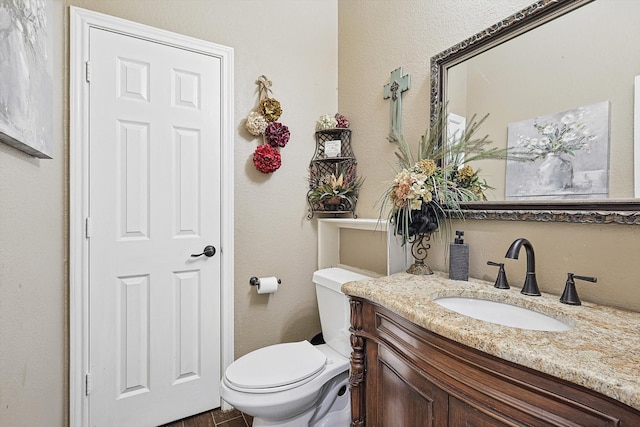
[{"xmin": 350, "ymin": 297, "xmax": 640, "ymax": 427}]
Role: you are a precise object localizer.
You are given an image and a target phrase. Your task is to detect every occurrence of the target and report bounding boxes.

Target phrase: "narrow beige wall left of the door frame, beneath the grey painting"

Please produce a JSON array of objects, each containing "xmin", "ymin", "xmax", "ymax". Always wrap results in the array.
[{"xmin": 0, "ymin": 0, "xmax": 68, "ymax": 426}]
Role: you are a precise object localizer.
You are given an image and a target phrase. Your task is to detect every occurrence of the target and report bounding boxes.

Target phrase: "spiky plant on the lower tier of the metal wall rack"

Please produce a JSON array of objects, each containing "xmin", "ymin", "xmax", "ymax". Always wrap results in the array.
[{"xmin": 309, "ymin": 165, "xmax": 364, "ymax": 210}]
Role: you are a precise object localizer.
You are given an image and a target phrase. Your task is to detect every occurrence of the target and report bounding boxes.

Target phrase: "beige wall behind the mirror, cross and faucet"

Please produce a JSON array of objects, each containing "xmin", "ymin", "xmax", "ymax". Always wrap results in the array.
[{"xmin": 338, "ymin": 0, "xmax": 640, "ymax": 311}]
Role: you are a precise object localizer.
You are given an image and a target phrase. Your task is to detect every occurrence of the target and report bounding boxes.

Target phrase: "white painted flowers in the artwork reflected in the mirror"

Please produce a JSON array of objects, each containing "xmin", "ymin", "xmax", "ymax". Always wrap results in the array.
[{"xmin": 516, "ymin": 109, "xmax": 596, "ymax": 158}]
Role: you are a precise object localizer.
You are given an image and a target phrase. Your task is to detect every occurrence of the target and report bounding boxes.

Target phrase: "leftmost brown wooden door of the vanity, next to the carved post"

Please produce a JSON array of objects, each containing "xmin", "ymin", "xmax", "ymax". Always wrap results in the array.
[{"xmin": 367, "ymin": 346, "xmax": 447, "ymax": 427}]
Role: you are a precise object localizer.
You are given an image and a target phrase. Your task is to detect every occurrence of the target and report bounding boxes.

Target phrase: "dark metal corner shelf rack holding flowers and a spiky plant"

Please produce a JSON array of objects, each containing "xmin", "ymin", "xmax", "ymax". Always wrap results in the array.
[{"xmin": 307, "ymin": 114, "xmax": 364, "ymax": 219}]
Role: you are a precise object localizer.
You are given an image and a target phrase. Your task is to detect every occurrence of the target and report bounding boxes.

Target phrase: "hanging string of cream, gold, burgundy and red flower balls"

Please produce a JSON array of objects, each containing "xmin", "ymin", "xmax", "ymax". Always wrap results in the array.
[{"xmin": 245, "ymin": 75, "xmax": 291, "ymax": 173}]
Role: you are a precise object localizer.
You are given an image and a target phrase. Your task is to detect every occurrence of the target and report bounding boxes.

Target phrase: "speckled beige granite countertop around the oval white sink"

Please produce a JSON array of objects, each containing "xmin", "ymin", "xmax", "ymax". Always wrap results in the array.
[{"xmin": 342, "ymin": 272, "xmax": 640, "ymax": 410}]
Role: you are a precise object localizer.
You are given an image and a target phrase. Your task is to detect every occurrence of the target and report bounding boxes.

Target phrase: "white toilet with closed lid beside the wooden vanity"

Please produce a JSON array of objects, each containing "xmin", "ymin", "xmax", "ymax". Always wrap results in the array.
[{"xmin": 221, "ymin": 268, "xmax": 370, "ymax": 427}]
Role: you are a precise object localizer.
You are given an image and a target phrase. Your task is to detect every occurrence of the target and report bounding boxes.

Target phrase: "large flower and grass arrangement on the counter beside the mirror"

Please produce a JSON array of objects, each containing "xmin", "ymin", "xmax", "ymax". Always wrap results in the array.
[{"xmin": 380, "ymin": 108, "xmax": 519, "ymax": 244}]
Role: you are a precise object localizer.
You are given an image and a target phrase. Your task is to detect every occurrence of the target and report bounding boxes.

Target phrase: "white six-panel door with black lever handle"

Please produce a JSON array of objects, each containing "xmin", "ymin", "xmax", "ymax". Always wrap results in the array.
[{"xmin": 88, "ymin": 28, "xmax": 221, "ymax": 427}]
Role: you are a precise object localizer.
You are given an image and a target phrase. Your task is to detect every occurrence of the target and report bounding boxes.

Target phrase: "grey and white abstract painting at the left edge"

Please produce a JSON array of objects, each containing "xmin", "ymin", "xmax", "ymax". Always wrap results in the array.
[{"xmin": 0, "ymin": 0, "xmax": 53, "ymax": 159}]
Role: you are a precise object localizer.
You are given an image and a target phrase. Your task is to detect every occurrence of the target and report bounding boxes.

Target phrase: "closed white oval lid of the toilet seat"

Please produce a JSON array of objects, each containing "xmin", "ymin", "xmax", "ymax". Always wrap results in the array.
[{"xmin": 225, "ymin": 341, "xmax": 327, "ymax": 392}]
